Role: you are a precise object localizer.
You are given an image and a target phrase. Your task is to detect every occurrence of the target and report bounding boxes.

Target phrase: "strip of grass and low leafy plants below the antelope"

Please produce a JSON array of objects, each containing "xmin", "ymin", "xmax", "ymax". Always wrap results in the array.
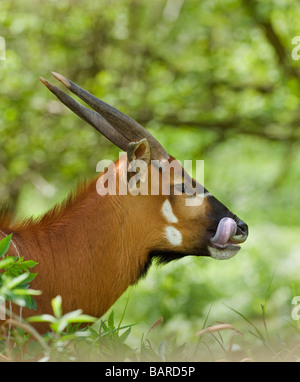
[{"xmin": 0, "ymin": 296, "xmax": 300, "ymax": 362}]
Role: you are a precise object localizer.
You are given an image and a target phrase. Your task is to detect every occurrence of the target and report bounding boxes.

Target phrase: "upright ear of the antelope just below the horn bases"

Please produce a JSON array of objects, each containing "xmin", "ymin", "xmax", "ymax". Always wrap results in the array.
[{"xmin": 127, "ymin": 138, "xmax": 151, "ymax": 195}]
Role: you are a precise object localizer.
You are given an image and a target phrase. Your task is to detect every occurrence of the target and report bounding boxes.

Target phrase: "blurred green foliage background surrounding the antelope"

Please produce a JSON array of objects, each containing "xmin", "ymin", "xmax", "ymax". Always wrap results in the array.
[{"xmin": 0, "ymin": 0, "xmax": 300, "ymax": 358}]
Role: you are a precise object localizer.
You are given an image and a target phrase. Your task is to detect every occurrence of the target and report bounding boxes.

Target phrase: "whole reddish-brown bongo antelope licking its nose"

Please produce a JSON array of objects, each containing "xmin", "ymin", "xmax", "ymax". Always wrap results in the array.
[{"xmin": 0, "ymin": 73, "xmax": 248, "ymax": 317}]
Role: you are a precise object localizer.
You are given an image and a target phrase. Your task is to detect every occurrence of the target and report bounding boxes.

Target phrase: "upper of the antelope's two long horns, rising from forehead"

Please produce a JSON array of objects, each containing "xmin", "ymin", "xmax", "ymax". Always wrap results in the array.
[{"xmin": 42, "ymin": 72, "xmax": 169, "ymax": 159}]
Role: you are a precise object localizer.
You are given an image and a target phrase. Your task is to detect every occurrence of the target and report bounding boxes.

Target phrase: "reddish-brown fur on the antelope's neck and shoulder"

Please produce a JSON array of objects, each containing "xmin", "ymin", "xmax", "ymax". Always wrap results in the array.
[{"xmin": 0, "ymin": 154, "xmax": 212, "ymax": 326}]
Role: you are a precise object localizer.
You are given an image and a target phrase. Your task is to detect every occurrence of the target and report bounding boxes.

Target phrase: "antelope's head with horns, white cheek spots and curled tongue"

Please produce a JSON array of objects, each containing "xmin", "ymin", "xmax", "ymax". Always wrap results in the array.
[{"xmin": 41, "ymin": 73, "xmax": 248, "ymax": 273}]
